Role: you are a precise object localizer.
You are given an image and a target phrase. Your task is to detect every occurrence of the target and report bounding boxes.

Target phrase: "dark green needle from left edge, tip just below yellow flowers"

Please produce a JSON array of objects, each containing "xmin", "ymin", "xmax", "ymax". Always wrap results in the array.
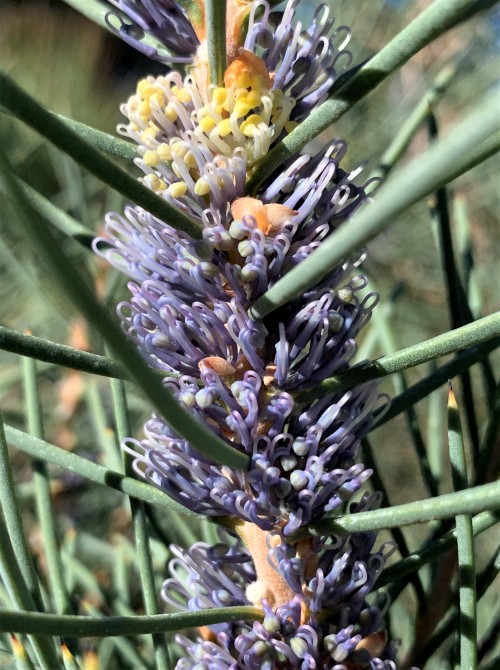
[{"xmin": 0, "ymin": 72, "xmax": 201, "ymax": 239}]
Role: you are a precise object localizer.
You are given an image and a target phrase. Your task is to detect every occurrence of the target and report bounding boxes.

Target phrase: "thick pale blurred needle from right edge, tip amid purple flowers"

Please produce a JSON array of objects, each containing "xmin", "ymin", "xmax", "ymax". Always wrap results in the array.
[{"xmin": 250, "ymin": 93, "xmax": 500, "ymax": 319}]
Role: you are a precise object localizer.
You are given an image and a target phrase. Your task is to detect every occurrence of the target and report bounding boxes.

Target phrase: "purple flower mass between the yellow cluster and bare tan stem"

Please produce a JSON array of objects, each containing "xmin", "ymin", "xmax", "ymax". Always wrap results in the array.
[{"xmin": 97, "ymin": 142, "xmax": 378, "ymax": 535}]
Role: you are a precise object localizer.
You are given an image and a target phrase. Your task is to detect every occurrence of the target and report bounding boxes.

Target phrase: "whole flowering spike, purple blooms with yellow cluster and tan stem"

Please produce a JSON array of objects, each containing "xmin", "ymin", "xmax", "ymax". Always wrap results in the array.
[{"xmin": 95, "ymin": 0, "xmax": 416, "ymax": 670}]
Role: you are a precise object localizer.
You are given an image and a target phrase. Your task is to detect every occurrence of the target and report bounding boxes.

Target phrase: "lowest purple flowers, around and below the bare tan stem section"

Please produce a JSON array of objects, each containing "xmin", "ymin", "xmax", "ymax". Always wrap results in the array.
[{"xmin": 162, "ymin": 516, "xmax": 404, "ymax": 670}]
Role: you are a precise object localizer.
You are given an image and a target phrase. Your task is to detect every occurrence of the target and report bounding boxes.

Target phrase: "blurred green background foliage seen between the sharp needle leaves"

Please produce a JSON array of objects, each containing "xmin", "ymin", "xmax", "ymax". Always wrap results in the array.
[{"xmin": 0, "ymin": 0, "xmax": 500, "ymax": 669}]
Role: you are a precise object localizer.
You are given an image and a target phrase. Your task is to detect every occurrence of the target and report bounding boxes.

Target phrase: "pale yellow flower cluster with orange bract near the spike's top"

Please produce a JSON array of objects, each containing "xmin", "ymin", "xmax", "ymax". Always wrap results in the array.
[{"xmin": 121, "ymin": 49, "xmax": 294, "ymax": 198}]
